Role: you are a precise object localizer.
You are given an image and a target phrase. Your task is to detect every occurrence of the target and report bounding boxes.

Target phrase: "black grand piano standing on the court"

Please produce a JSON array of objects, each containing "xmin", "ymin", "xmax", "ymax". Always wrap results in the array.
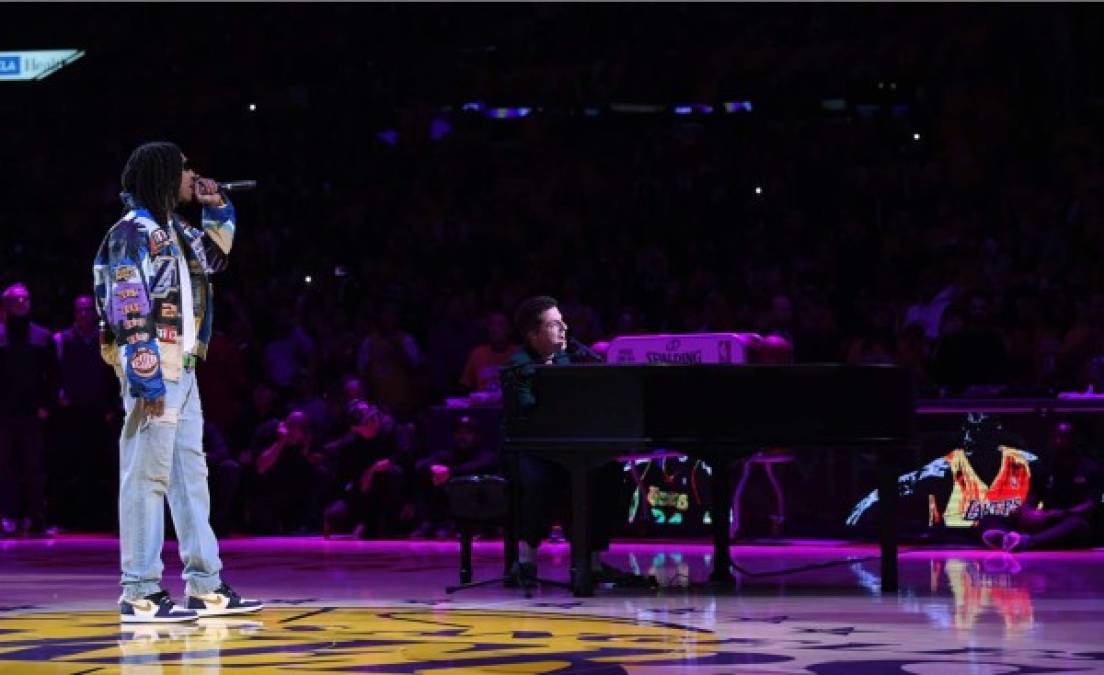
[{"xmin": 502, "ymin": 362, "xmax": 915, "ymax": 597}]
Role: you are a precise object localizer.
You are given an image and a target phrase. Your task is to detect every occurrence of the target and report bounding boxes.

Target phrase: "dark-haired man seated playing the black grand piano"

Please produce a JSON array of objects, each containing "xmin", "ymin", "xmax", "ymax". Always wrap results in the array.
[{"xmin": 501, "ymin": 295, "xmax": 655, "ymax": 587}]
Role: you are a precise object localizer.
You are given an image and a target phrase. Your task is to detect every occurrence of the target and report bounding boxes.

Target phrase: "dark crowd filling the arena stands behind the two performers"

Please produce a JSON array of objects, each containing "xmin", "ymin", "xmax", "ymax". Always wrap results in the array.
[{"xmin": 0, "ymin": 2, "xmax": 1104, "ymax": 536}]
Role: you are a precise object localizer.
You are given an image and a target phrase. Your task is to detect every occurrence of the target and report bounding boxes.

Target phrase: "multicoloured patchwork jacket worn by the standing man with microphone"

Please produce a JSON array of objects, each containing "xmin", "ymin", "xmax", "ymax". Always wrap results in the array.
[{"xmin": 92, "ymin": 192, "xmax": 235, "ymax": 400}]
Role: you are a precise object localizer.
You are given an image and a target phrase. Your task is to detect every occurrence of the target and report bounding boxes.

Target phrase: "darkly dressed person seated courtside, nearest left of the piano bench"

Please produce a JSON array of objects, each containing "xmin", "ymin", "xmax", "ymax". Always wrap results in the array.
[{"xmin": 411, "ymin": 415, "xmax": 498, "ymax": 539}]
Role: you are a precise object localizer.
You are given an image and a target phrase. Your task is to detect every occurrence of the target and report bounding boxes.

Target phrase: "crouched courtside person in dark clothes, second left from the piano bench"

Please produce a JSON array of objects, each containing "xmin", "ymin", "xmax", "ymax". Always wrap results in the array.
[{"xmin": 322, "ymin": 400, "xmax": 414, "ymax": 538}]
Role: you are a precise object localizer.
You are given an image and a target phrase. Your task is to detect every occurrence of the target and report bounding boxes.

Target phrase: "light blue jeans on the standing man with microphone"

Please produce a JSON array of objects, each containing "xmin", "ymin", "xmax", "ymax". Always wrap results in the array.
[{"xmin": 119, "ymin": 370, "xmax": 222, "ymax": 600}]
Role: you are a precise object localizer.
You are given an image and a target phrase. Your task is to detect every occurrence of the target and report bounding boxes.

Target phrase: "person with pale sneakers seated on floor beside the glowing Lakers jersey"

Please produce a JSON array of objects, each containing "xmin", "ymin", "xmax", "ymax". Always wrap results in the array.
[{"xmin": 981, "ymin": 422, "xmax": 1104, "ymax": 551}]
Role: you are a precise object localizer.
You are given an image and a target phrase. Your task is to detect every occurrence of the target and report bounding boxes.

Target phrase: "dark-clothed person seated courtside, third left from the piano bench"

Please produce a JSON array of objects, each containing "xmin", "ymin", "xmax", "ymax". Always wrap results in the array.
[{"xmin": 248, "ymin": 410, "xmax": 328, "ymax": 534}]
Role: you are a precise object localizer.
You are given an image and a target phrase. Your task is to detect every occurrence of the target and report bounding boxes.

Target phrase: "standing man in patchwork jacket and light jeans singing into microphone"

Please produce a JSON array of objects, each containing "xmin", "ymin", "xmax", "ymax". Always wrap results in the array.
[{"xmin": 93, "ymin": 143, "xmax": 262, "ymax": 623}]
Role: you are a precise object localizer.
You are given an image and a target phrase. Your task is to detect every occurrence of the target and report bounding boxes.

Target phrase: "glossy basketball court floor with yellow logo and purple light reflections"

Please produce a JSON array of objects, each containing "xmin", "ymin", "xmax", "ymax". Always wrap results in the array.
[{"xmin": 0, "ymin": 536, "xmax": 1104, "ymax": 675}]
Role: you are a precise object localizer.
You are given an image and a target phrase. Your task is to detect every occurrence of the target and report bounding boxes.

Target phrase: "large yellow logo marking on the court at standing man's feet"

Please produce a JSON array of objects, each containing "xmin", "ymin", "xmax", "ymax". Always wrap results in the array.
[{"xmin": 0, "ymin": 608, "xmax": 786, "ymax": 673}]
